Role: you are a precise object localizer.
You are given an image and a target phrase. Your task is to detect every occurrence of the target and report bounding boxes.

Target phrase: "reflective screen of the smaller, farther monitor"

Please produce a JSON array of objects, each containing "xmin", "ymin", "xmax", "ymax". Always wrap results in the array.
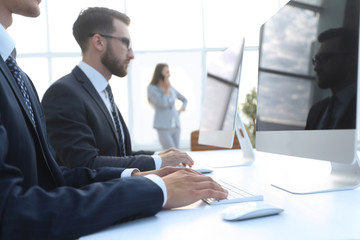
[{"xmin": 200, "ymin": 40, "xmax": 244, "ymax": 130}]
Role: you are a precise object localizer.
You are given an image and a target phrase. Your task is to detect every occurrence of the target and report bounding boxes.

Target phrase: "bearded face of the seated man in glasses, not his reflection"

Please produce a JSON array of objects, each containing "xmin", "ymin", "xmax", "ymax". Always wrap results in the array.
[{"xmin": 101, "ymin": 20, "xmax": 134, "ymax": 77}]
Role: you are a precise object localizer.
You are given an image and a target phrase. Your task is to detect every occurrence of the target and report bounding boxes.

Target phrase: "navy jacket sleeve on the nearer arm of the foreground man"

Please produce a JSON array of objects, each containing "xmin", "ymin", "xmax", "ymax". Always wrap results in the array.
[{"xmin": 0, "ymin": 125, "xmax": 163, "ymax": 239}]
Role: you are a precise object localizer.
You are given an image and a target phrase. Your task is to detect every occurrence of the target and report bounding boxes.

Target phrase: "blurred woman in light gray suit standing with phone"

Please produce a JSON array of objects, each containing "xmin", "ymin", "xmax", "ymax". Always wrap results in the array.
[{"xmin": 147, "ymin": 63, "xmax": 187, "ymax": 149}]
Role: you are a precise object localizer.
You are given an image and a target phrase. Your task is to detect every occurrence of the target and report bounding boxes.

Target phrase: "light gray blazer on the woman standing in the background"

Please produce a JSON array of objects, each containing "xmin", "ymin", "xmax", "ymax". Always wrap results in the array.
[{"xmin": 147, "ymin": 85, "xmax": 187, "ymax": 128}]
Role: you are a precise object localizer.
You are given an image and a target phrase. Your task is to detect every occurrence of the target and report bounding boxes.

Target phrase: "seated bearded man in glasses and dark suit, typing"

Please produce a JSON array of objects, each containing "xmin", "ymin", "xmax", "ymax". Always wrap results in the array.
[{"xmin": 42, "ymin": 7, "xmax": 193, "ymax": 170}]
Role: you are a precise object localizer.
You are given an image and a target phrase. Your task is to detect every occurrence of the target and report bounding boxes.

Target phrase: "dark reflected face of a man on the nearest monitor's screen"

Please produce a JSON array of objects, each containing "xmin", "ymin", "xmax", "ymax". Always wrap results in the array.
[{"xmin": 314, "ymin": 38, "xmax": 346, "ymax": 89}]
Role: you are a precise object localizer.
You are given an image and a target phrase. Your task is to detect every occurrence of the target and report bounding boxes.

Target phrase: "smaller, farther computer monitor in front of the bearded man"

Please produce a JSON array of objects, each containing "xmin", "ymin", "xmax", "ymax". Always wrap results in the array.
[{"xmin": 198, "ymin": 39, "xmax": 254, "ymax": 166}]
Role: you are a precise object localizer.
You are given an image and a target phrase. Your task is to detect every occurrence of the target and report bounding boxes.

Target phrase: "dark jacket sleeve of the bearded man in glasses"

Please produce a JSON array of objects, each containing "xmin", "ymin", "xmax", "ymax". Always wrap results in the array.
[{"xmin": 42, "ymin": 78, "xmax": 155, "ymax": 171}]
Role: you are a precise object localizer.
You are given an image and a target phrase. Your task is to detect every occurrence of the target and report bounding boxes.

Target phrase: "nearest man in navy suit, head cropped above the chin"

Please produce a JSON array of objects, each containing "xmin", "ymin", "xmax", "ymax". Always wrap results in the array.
[{"xmin": 0, "ymin": 0, "xmax": 227, "ymax": 239}]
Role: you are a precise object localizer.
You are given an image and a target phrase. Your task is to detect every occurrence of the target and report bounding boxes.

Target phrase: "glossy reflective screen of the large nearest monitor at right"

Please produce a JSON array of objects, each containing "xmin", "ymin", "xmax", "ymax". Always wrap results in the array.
[{"xmin": 256, "ymin": 0, "xmax": 359, "ymax": 131}]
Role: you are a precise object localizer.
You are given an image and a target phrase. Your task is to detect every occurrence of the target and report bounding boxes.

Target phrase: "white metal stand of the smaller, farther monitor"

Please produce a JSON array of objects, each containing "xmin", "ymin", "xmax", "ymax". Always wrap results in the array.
[{"xmin": 207, "ymin": 111, "xmax": 255, "ymax": 168}]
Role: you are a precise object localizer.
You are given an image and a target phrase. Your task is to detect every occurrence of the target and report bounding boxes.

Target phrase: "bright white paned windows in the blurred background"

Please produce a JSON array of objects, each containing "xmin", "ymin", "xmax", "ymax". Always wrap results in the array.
[{"xmin": 9, "ymin": 0, "xmax": 300, "ymax": 150}]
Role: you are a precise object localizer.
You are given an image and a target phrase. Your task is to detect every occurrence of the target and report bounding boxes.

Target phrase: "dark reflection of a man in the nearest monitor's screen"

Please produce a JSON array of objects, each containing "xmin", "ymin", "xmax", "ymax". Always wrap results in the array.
[{"xmin": 305, "ymin": 28, "xmax": 359, "ymax": 130}]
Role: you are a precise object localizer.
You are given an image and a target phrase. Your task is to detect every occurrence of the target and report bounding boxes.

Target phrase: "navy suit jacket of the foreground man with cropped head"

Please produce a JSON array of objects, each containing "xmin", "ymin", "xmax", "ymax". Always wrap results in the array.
[{"xmin": 0, "ymin": 58, "xmax": 163, "ymax": 239}]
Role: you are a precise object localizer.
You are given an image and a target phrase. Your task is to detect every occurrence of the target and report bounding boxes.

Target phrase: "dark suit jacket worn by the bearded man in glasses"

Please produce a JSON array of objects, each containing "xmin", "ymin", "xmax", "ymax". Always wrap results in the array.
[{"xmin": 42, "ymin": 67, "xmax": 155, "ymax": 171}]
